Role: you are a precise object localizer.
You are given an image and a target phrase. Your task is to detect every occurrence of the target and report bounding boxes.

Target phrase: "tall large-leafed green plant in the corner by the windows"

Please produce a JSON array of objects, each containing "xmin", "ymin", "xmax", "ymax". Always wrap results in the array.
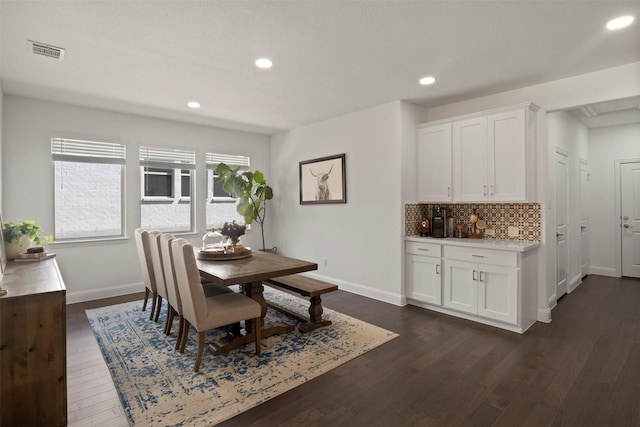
[{"xmin": 215, "ymin": 163, "xmax": 273, "ymax": 251}]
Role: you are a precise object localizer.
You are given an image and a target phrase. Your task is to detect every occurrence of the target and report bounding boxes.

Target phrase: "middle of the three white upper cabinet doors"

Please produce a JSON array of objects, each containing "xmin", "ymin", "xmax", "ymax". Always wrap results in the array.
[{"xmin": 452, "ymin": 117, "xmax": 488, "ymax": 202}]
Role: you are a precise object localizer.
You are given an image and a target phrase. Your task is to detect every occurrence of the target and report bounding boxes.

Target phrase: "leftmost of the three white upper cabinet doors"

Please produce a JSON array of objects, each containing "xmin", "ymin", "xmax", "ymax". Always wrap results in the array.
[{"xmin": 416, "ymin": 123, "xmax": 452, "ymax": 202}]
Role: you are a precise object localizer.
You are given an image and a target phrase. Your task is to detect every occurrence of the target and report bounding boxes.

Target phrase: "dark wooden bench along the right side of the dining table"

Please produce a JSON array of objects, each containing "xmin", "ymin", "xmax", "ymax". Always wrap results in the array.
[{"xmin": 263, "ymin": 274, "xmax": 338, "ymax": 332}]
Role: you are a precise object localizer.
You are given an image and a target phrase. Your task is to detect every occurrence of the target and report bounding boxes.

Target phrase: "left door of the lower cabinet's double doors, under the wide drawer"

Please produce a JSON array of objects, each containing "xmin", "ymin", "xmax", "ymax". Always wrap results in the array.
[{"xmin": 443, "ymin": 259, "xmax": 478, "ymax": 314}]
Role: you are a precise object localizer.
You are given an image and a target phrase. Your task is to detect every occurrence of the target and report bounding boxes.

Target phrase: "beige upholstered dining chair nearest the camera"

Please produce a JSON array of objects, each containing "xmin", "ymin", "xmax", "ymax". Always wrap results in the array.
[{"xmin": 171, "ymin": 239, "xmax": 262, "ymax": 372}]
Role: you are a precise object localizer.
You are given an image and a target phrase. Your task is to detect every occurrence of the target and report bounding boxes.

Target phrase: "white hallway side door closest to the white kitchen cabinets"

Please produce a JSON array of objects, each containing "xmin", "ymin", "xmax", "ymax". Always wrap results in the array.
[{"xmin": 555, "ymin": 151, "xmax": 569, "ymax": 299}]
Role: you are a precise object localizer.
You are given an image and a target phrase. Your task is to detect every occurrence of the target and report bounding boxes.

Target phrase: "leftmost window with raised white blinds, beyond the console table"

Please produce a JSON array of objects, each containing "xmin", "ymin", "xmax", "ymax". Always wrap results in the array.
[{"xmin": 51, "ymin": 138, "xmax": 126, "ymax": 240}]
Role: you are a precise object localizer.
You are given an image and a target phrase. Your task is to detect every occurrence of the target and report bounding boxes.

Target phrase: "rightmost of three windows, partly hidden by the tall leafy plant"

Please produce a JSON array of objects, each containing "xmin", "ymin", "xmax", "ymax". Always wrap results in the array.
[{"xmin": 206, "ymin": 153, "xmax": 249, "ymax": 228}]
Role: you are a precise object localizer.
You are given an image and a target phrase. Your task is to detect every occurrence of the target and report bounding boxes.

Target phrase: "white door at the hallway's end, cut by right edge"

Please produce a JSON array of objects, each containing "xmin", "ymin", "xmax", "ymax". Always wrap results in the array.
[{"xmin": 620, "ymin": 163, "xmax": 640, "ymax": 277}]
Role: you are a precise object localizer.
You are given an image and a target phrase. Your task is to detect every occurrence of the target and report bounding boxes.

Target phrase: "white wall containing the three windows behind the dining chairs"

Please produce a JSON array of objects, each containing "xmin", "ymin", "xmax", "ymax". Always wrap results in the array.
[{"xmin": 2, "ymin": 96, "xmax": 272, "ymax": 302}]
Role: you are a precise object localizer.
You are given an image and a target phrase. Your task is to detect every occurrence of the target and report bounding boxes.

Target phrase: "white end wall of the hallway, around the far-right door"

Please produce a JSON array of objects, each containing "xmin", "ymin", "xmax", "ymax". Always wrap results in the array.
[{"xmin": 589, "ymin": 124, "xmax": 640, "ymax": 277}]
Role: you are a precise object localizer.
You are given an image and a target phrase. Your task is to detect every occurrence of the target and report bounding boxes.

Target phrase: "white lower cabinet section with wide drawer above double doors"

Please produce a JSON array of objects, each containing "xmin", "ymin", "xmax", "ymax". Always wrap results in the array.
[{"xmin": 443, "ymin": 247, "xmax": 520, "ymax": 325}]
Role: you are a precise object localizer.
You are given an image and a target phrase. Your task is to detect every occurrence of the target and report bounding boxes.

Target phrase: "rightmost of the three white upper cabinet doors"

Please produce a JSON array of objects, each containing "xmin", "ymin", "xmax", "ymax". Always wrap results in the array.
[{"xmin": 487, "ymin": 110, "xmax": 527, "ymax": 201}]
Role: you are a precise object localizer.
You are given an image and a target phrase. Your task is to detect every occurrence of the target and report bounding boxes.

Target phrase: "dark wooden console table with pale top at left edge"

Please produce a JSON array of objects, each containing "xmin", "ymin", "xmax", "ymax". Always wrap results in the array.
[{"xmin": 0, "ymin": 259, "xmax": 67, "ymax": 427}]
